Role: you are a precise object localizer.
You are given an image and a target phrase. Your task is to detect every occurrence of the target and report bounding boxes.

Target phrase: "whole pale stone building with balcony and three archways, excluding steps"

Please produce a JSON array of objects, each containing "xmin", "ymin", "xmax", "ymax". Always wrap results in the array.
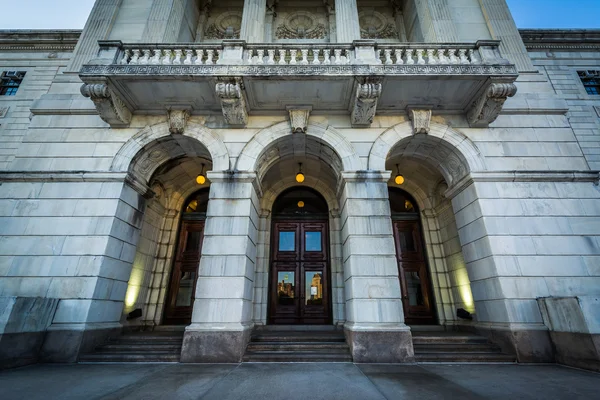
[{"xmin": 0, "ymin": 0, "xmax": 600, "ymax": 368}]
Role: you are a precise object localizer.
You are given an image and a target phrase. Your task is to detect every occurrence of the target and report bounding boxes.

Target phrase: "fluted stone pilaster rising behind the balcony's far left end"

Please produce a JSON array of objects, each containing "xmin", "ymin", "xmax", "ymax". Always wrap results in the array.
[{"xmin": 67, "ymin": 0, "xmax": 123, "ymax": 72}]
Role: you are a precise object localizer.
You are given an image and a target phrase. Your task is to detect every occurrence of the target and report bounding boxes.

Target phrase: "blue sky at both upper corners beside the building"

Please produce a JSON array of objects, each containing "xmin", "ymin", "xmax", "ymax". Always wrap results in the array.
[{"xmin": 0, "ymin": 0, "xmax": 600, "ymax": 29}]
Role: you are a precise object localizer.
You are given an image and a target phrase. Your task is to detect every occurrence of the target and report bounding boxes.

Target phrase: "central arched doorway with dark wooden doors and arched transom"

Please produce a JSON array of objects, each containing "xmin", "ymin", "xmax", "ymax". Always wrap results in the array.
[{"xmin": 268, "ymin": 187, "xmax": 332, "ymax": 325}]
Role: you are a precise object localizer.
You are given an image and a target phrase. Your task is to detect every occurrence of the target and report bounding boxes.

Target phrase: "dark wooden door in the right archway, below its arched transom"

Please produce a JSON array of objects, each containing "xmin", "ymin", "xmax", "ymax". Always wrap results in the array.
[{"xmin": 393, "ymin": 221, "xmax": 435, "ymax": 325}]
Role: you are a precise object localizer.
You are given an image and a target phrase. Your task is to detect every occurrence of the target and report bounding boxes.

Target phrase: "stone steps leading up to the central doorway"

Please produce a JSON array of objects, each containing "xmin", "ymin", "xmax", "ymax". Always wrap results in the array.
[{"xmin": 243, "ymin": 325, "xmax": 352, "ymax": 362}]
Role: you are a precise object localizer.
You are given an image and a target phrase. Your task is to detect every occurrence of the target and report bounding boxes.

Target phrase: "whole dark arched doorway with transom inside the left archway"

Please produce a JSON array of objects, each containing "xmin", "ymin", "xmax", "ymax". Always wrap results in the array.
[{"xmin": 163, "ymin": 188, "xmax": 209, "ymax": 325}]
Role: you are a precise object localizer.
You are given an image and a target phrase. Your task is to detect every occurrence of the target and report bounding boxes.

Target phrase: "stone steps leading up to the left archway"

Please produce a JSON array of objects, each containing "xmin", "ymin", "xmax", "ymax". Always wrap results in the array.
[{"xmin": 79, "ymin": 330, "xmax": 183, "ymax": 363}]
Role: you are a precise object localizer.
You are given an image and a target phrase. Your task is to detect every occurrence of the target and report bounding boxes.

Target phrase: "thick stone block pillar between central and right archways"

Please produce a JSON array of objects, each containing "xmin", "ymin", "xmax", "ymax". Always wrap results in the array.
[{"xmin": 340, "ymin": 171, "xmax": 414, "ymax": 363}]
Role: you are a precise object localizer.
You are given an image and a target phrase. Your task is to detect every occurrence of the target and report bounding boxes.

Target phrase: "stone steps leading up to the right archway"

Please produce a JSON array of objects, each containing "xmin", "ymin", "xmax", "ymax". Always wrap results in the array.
[{"xmin": 412, "ymin": 330, "xmax": 516, "ymax": 363}]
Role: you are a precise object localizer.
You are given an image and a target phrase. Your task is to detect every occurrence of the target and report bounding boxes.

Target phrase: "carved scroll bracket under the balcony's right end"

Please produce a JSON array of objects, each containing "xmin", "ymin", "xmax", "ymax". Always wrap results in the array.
[{"xmin": 467, "ymin": 83, "xmax": 517, "ymax": 128}]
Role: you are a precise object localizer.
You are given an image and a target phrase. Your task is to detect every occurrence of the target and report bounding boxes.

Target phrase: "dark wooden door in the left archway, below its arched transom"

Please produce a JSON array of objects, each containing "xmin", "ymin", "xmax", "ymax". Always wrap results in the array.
[{"xmin": 164, "ymin": 220, "xmax": 204, "ymax": 325}]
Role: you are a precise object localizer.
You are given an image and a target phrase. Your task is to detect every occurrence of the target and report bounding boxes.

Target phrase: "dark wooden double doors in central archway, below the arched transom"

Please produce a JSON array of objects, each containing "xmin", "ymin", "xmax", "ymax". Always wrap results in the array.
[{"xmin": 269, "ymin": 220, "xmax": 331, "ymax": 324}]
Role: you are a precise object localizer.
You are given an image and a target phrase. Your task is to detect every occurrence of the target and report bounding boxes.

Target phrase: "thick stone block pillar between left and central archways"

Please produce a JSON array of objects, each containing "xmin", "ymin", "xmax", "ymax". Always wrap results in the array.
[{"xmin": 181, "ymin": 172, "xmax": 259, "ymax": 363}]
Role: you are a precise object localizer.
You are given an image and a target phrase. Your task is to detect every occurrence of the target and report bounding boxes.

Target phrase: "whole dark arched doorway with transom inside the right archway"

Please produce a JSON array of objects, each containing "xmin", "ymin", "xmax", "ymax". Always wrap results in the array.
[{"xmin": 389, "ymin": 187, "xmax": 436, "ymax": 325}]
